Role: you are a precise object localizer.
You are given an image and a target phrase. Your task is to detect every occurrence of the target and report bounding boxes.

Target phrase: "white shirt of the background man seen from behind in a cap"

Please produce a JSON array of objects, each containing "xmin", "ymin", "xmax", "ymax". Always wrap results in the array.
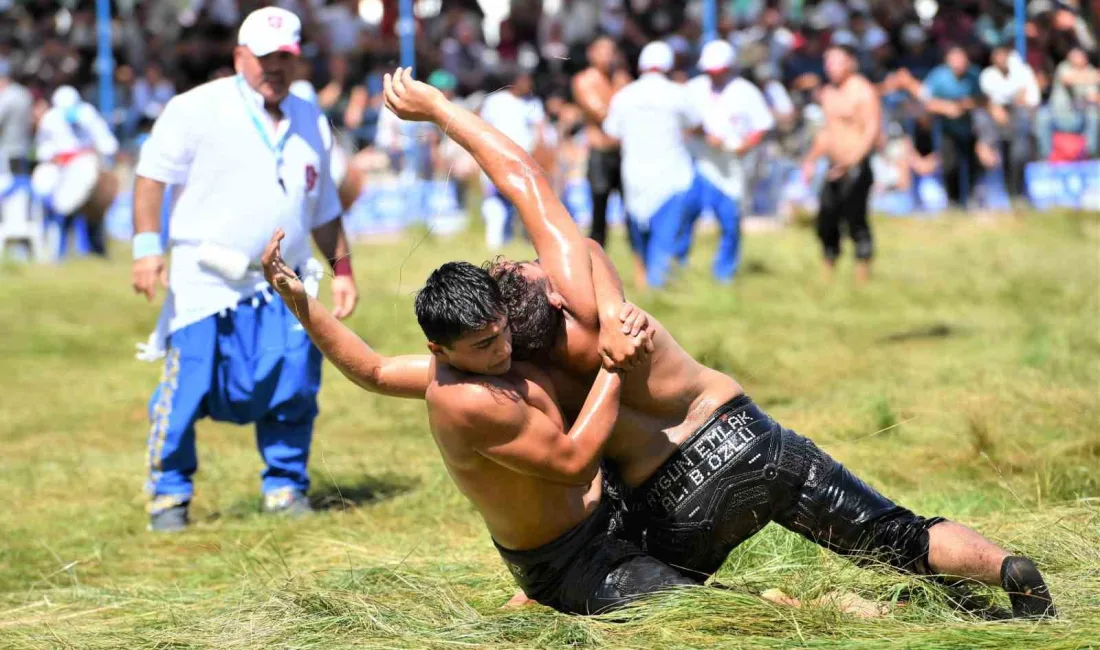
[{"xmin": 603, "ymin": 73, "xmax": 703, "ymax": 227}]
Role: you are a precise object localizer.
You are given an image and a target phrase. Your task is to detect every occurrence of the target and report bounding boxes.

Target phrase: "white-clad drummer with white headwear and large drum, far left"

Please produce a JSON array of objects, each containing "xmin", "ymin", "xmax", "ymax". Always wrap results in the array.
[{"xmin": 31, "ymin": 86, "xmax": 119, "ymax": 251}]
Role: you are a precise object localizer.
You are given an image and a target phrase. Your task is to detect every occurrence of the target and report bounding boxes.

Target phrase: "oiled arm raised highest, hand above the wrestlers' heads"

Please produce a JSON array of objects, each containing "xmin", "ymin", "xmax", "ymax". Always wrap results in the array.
[{"xmin": 383, "ymin": 68, "xmax": 598, "ymax": 327}]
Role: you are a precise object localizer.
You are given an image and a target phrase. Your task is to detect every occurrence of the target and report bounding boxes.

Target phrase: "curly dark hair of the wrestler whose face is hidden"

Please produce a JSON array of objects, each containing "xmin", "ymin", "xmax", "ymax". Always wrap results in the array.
[{"xmin": 485, "ymin": 257, "xmax": 562, "ymax": 361}]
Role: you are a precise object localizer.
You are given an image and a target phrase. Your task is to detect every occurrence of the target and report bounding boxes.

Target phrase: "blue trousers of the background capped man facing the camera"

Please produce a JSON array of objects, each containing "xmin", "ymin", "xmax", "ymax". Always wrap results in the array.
[{"xmin": 677, "ymin": 174, "xmax": 741, "ymax": 282}]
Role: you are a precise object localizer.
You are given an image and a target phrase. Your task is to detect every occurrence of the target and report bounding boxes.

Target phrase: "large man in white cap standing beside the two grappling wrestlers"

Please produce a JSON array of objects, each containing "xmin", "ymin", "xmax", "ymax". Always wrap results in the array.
[{"xmin": 133, "ymin": 7, "xmax": 358, "ymax": 531}]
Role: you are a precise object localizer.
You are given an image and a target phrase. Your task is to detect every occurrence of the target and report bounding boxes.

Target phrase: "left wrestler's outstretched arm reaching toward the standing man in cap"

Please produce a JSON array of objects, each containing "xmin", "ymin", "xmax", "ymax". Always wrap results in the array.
[{"xmin": 263, "ymin": 229, "xmax": 431, "ymax": 399}]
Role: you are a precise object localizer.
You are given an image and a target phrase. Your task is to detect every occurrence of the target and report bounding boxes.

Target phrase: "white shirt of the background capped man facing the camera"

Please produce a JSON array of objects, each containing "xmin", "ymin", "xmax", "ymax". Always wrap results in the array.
[{"xmin": 688, "ymin": 75, "xmax": 776, "ymax": 199}]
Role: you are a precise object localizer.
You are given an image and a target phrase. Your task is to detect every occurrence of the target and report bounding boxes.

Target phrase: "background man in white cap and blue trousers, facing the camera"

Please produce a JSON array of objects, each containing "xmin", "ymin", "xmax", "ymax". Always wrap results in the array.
[{"xmin": 677, "ymin": 41, "xmax": 776, "ymax": 282}]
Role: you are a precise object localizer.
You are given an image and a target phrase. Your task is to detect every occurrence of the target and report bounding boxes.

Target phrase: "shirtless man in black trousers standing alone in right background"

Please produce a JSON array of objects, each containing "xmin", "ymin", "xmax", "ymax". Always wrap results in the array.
[{"xmin": 802, "ymin": 45, "xmax": 882, "ymax": 283}]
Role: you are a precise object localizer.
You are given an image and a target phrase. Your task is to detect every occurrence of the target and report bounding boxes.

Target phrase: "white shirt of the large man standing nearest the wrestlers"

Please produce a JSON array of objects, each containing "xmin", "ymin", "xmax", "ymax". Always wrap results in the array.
[{"xmin": 136, "ymin": 77, "xmax": 342, "ymax": 331}]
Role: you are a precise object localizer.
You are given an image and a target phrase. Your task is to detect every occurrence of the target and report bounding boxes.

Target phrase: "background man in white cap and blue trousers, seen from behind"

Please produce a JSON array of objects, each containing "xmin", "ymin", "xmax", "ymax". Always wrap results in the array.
[{"xmin": 603, "ymin": 41, "xmax": 703, "ymax": 287}]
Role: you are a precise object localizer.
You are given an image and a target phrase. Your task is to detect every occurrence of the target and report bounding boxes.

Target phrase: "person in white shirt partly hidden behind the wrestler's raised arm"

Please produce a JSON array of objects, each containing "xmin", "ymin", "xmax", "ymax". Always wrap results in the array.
[{"xmin": 481, "ymin": 69, "xmax": 546, "ymax": 251}]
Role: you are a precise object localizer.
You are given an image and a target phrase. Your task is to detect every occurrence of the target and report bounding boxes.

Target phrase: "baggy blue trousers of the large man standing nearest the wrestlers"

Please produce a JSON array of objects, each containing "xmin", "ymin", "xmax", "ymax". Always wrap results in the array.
[{"xmin": 146, "ymin": 293, "xmax": 322, "ymax": 513}]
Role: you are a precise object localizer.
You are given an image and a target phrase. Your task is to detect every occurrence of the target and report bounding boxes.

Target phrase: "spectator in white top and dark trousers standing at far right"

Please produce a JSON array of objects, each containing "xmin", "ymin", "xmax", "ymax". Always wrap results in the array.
[{"xmin": 976, "ymin": 42, "xmax": 1041, "ymax": 197}]
